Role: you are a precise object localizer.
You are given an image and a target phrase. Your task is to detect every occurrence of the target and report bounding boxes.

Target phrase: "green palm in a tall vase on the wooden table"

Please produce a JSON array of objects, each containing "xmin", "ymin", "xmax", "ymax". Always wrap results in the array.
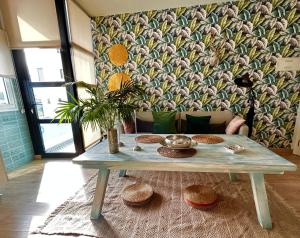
[{"xmin": 56, "ymin": 81, "xmax": 144, "ymax": 154}]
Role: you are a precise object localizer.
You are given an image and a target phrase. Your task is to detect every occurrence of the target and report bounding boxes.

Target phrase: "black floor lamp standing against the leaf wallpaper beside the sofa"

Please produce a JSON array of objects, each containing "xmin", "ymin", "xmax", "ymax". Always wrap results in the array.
[{"xmin": 234, "ymin": 73, "xmax": 255, "ymax": 137}]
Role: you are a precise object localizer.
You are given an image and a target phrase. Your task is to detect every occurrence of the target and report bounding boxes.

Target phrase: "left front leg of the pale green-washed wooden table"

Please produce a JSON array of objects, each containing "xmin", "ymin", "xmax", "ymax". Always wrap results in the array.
[{"xmin": 91, "ymin": 169, "xmax": 110, "ymax": 219}]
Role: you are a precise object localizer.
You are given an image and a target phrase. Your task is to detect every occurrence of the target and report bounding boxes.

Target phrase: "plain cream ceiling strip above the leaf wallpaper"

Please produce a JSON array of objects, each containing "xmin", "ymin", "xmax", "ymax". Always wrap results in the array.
[{"xmin": 74, "ymin": 0, "xmax": 232, "ymax": 16}]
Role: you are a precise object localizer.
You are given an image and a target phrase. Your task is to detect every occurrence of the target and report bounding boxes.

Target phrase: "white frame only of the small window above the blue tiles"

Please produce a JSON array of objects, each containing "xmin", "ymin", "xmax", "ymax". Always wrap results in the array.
[{"xmin": 0, "ymin": 75, "xmax": 18, "ymax": 112}]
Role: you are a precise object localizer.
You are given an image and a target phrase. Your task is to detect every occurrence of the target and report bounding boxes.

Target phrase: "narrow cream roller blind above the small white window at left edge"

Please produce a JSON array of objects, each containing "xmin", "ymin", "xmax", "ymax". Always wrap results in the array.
[{"xmin": 0, "ymin": 30, "xmax": 15, "ymax": 78}]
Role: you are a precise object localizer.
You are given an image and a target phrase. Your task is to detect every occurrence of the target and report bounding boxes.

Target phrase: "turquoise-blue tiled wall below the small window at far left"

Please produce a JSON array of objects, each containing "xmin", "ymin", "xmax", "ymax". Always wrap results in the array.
[{"xmin": 0, "ymin": 80, "xmax": 34, "ymax": 171}]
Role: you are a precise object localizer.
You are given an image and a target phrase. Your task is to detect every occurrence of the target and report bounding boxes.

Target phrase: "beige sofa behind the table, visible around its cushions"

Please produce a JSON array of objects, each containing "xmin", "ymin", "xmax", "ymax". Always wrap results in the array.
[{"xmin": 136, "ymin": 111, "xmax": 249, "ymax": 136}]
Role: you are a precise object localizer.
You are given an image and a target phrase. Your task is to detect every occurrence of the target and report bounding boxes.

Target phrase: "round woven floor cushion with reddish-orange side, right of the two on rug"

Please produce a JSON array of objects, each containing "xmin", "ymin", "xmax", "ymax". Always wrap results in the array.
[{"xmin": 183, "ymin": 185, "xmax": 218, "ymax": 210}]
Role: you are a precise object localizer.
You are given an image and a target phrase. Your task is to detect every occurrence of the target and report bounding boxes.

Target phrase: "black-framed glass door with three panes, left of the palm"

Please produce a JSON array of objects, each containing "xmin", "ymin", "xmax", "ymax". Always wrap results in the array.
[{"xmin": 13, "ymin": 48, "xmax": 82, "ymax": 157}]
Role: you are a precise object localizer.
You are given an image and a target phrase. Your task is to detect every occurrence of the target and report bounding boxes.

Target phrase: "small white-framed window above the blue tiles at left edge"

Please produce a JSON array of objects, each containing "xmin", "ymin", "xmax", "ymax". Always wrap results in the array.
[{"xmin": 0, "ymin": 77, "xmax": 17, "ymax": 112}]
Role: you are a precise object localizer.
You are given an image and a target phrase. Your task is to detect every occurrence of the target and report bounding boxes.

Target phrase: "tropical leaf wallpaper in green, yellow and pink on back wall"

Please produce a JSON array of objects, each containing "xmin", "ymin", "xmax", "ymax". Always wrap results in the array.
[{"xmin": 92, "ymin": 0, "xmax": 300, "ymax": 147}]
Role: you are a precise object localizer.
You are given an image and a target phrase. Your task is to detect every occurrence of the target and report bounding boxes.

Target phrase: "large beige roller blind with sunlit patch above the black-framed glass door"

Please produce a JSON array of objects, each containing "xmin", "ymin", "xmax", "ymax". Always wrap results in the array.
[{"xmin": 0, "ymin": 0, "xmax": 60, "ymax": 48}]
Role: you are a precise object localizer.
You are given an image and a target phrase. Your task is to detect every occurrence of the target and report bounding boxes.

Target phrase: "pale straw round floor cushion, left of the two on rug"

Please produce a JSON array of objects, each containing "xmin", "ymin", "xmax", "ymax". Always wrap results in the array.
[{"xmin": 121, "ymin": 183, "xmax": 153, "ymax": 206}]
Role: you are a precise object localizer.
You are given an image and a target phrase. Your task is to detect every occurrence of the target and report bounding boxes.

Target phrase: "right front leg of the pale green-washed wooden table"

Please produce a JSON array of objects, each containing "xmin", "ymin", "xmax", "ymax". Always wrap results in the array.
[{"xmin": 250, "ymin": 173, "xmax": 272, "ymax": 229}]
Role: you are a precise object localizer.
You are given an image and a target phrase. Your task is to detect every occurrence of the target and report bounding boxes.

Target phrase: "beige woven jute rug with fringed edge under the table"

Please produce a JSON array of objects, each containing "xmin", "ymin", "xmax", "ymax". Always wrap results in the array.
[{"xmin": 33, "ymin": 171, "xmax": 300, "ymax": 238}]
